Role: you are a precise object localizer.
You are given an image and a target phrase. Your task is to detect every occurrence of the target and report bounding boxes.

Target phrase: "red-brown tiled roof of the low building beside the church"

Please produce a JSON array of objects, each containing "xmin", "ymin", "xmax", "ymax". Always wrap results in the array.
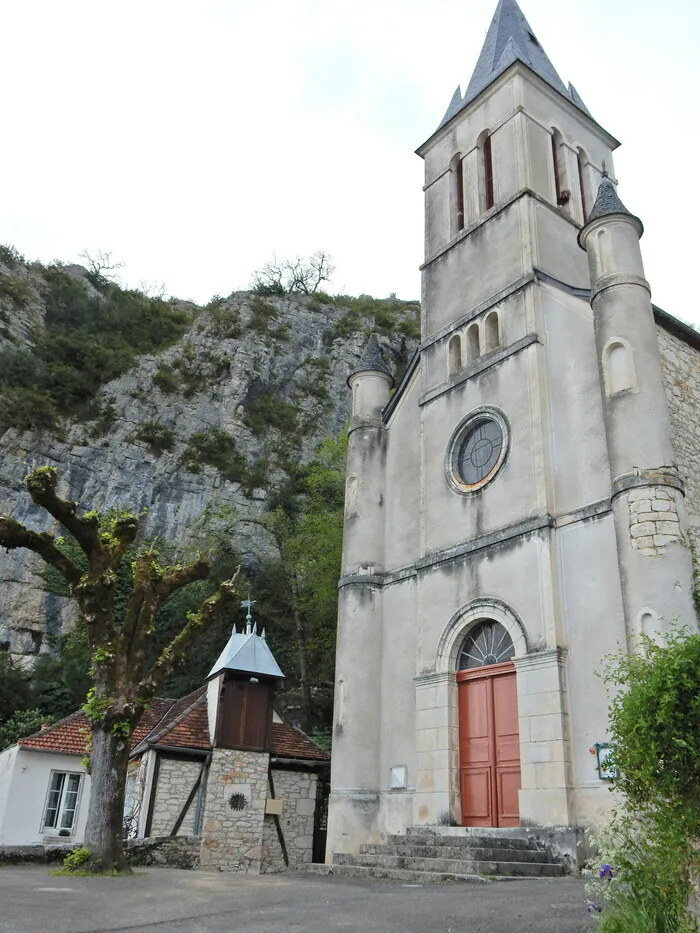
[{"xmin": 19, "ymin": 687, "xmax": 329, "ymax": 761}]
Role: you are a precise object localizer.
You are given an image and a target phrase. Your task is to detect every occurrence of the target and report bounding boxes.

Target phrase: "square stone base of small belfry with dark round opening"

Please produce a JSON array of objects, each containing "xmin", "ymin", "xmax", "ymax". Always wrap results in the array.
[{"xmin": 200, "ymin": 748, "xmax": 270, "ymax": 875}]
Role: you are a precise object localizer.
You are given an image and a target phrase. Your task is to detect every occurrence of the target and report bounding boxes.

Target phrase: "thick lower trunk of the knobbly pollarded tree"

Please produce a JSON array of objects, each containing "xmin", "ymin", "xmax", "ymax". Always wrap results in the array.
[{"xmin": 83, "ymin": 723, "xmax": 131, "ymax": 872}]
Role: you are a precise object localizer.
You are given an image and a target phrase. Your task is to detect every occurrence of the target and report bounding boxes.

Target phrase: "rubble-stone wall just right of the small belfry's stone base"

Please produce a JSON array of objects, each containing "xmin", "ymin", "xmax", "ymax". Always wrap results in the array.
[{"xmin": 260, "ymin": 768, "xmax": 317, "ymax": 872}]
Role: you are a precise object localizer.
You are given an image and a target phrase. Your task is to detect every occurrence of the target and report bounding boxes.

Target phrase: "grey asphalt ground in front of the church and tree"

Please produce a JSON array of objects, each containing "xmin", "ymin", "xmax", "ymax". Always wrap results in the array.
[{"xmin": 0, "ymin": 866, "xmax": 591, "ymax": 933}]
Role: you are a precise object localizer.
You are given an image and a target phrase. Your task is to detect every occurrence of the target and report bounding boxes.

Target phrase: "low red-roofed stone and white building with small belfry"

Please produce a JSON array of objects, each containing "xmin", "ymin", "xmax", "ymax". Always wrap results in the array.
[{"xmin": 0, "ymin": 626, "xmax": 329, "ymax": 874}]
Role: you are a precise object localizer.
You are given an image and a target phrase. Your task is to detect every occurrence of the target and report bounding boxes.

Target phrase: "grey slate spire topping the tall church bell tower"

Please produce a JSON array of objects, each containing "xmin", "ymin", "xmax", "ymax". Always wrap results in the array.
[{"xmin": 440, "ymin": 0, "xmax": 590, "ymax": 126}]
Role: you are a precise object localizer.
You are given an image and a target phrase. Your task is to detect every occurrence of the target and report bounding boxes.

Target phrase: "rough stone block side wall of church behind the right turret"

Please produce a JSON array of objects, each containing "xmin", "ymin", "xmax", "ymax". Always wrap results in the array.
[{"xmin": 656, "ymin": 326, "xmax": 700, "ymax": 528}]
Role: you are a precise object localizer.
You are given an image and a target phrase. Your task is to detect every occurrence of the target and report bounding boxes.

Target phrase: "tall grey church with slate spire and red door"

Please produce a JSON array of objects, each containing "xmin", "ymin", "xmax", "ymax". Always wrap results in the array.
[{"xmin": 327, "ymin": 0, "xmax": 700, "ymax": 858}]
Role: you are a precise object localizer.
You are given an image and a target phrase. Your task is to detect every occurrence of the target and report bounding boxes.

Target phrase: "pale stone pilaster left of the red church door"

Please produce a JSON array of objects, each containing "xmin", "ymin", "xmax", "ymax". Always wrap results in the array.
[{"xmin": 413, "ymin": 671, "xmax": 462, "ymax": 825}]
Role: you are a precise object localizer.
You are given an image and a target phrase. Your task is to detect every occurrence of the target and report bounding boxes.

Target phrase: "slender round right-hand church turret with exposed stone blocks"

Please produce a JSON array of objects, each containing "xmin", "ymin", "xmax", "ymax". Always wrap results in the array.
[{"xmin": 579, "ymin": 171, "xmax": 695, "ymax": 638}]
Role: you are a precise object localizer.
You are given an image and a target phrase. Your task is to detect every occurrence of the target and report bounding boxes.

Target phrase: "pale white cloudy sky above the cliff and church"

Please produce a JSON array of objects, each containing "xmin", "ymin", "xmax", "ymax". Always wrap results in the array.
[{"xmin": 0, "ymin": 0, "xmax": 700, "ymax": 323}]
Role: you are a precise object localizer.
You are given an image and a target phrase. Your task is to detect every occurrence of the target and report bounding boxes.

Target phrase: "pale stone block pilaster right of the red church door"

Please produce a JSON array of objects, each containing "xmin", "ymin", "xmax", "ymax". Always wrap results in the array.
[{"xmin": 515, "ymin": 648, "xmax": 571, "ymax": 826}]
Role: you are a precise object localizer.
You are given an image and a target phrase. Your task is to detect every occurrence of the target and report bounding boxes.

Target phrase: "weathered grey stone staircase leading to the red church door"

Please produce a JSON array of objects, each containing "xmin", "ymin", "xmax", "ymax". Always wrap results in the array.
[{"xmin": 309, "ymin": 826, "xmax": 566, "ymax": 884}]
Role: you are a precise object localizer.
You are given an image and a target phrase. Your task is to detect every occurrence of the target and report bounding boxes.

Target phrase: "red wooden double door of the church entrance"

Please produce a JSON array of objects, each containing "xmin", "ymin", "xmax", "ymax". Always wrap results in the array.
[{"xmin": 457, "ymin": 662, "xmax": 520, "ymax": 826}]
